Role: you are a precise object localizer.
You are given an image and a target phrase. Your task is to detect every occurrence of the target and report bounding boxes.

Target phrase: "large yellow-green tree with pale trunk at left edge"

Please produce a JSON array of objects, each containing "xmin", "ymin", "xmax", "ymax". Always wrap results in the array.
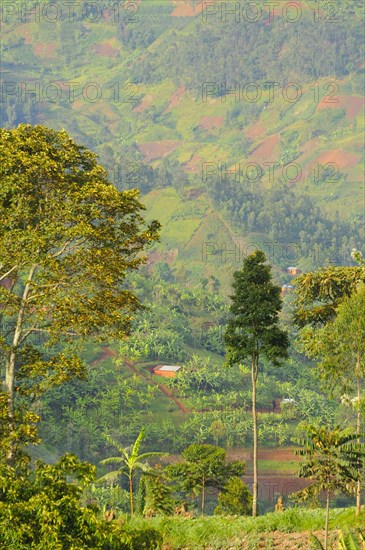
[{"xmin": 0, "ymin": 124, "xmax": 159, "ymax": 461}]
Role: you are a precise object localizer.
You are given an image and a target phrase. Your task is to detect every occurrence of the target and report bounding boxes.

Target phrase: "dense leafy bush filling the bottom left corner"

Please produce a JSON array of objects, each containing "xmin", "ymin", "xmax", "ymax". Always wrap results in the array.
[{"xmin": 0, "ymin": 455, "xmax": 160, "ymax": 550}]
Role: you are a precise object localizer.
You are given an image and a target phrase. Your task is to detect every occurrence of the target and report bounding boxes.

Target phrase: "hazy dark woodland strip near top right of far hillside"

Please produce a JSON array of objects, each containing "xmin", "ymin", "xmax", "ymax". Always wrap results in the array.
[{"xmin": 133, "ymin": 5, "xmax": 362, "ymax": 88}]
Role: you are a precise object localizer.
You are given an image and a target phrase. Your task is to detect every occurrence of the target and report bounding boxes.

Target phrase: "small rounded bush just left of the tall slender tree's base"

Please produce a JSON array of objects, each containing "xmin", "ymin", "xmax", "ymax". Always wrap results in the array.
[{"xmin": 214, "ymin": 477, "xmax": 252, "ymax": 516}]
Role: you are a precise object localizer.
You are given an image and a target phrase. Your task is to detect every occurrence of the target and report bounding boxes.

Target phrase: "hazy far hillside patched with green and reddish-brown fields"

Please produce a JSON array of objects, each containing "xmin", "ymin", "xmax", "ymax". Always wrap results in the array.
[{"xmin": 0, "ymin": 0, "xmax": 364, "ymax": 279}]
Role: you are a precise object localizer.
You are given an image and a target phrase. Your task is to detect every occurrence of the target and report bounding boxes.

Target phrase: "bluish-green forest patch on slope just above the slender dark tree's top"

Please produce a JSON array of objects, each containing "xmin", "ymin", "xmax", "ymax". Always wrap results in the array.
[{"xmin": 208, "ymin": 181, "xmax": 364, "ymax": 267}]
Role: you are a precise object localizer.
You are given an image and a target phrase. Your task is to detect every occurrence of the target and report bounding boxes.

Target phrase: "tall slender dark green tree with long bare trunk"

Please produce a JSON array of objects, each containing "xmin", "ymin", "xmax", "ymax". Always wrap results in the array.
[{"xmin": 224, "ymin": 250, "xmax": 289, "ymax": 516}]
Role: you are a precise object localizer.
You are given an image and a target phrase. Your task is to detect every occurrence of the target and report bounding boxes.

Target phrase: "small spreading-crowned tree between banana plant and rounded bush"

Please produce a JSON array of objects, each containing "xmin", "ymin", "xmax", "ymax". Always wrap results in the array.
[{"xmin": 167, "ymin": 444, "xmax": 245, "ymax": 515}]
